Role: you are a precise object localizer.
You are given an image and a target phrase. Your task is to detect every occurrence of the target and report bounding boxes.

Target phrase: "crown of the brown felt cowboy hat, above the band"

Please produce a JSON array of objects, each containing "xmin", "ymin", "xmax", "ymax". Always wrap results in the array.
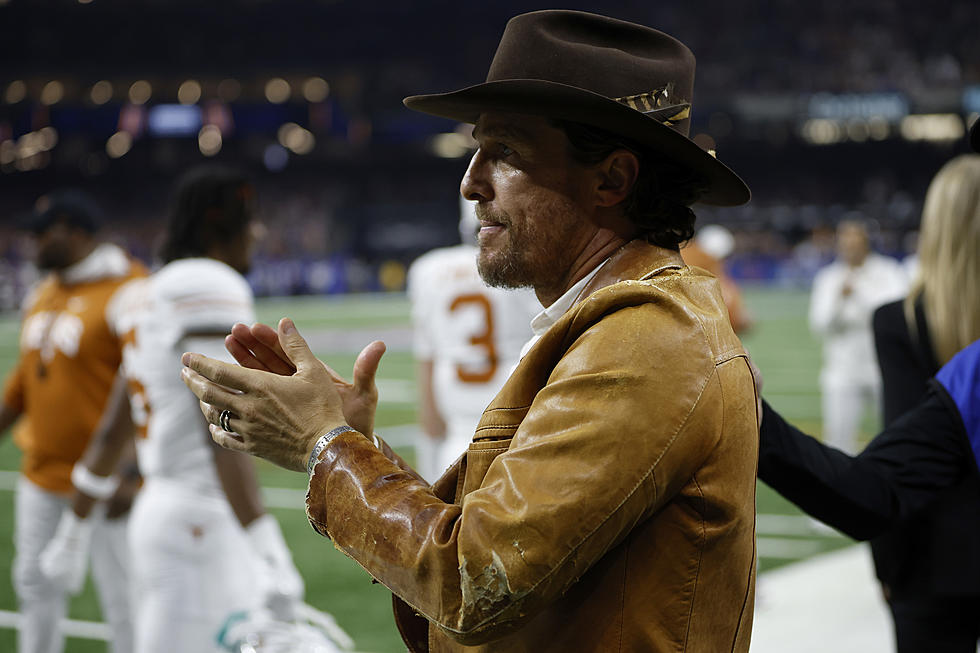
[{"xmin": 487, "ymin": 10, "xmax": 695, "ymax": 134}]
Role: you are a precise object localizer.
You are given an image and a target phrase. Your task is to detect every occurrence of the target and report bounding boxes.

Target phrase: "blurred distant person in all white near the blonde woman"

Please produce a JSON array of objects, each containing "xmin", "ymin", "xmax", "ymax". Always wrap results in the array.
[{"xmin": 810, "ymin": 220, "xmax": 908, "ymax": 454}]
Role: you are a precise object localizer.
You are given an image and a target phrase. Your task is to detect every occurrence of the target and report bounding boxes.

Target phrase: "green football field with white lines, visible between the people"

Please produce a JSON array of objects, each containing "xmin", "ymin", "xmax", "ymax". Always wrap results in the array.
[{"xmin": 0, "ymin": 288, "xmax": 864, "ymax": 653}]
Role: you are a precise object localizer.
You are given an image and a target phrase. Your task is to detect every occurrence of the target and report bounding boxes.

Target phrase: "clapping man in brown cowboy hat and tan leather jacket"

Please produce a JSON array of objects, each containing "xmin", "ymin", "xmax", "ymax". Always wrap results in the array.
[{"xmin": 183, "ymin": 11, "xmax": 758, "ymax": 653}]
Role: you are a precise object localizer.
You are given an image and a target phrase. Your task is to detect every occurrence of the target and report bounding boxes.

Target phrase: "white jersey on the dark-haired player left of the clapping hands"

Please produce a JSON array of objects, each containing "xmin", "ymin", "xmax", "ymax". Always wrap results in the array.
[{"xmin": 108, "ymin": 258, "xmax": 255, "ymax": 498}]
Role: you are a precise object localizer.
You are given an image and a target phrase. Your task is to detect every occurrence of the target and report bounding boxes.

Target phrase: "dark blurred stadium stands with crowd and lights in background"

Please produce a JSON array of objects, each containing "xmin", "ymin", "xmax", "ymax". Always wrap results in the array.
[{"xmin": 0, "ymin": 0, "xmax": 980, "ymax": 310}]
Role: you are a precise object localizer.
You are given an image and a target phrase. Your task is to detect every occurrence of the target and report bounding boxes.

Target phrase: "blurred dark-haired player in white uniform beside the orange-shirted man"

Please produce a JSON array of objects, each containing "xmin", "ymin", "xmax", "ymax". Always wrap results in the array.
[{"xmin": 42, "ymin": 168, "xmax": 303, "ymax": 653}]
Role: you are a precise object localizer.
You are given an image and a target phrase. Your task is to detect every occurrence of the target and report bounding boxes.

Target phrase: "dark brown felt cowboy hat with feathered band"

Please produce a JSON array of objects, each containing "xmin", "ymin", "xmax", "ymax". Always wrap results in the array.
[{"xmin": 405, "ymin": 10, "xmax": 750, "ymax": 206}]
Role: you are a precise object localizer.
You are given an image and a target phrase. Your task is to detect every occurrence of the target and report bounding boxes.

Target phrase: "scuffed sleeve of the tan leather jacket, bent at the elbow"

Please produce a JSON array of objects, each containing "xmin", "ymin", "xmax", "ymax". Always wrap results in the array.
[{"xmin": 307, "ymin": 304, "xmax": 732, "ymax": 644}]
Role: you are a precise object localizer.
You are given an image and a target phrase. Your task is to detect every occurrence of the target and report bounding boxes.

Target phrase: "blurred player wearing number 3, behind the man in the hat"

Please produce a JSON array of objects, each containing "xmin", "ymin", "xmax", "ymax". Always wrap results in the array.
[{"xmin": 408, "ymin": 198, "xmax": 541, "ymax": 482}]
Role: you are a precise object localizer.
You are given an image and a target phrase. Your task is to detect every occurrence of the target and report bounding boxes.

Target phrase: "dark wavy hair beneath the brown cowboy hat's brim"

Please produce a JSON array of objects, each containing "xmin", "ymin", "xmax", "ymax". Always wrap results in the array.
[{"xmin": 551, "ymin": 120, "xmax": 708, "ymax": 250}]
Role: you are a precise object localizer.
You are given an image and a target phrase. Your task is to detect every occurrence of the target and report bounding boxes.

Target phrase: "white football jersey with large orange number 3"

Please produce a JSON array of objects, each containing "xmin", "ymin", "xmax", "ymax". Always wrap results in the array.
[{"xmin": 408, "ymin": 245, "xmax": 541, "ymax": 438}]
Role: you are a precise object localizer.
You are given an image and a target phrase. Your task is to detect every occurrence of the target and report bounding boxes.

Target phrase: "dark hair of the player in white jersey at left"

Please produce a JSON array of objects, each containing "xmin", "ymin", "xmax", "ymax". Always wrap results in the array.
[{"xmin": 160, "ymin": 166, "xmax": 255, "ymax": 263}]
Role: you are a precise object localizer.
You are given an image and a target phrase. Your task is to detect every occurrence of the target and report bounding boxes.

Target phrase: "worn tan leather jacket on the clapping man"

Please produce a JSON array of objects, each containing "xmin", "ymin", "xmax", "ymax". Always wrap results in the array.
[{"xmin": 307, "ymin": 241, "xmax": 758, "ymax": 653}]
